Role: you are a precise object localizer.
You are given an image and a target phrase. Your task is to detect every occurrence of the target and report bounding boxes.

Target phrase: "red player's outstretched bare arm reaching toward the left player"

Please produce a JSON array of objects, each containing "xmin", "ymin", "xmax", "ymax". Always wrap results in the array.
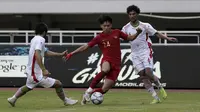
[{"xmin": 64, "ymin": 44, "xmax": 89, "ymax": 60}]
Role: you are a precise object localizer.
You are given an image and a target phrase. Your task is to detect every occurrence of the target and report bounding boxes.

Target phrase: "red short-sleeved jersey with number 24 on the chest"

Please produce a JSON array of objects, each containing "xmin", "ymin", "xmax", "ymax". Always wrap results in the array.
[{"xmin": 88, "ymin": 29, "xmax": 128, "ymax": 66}]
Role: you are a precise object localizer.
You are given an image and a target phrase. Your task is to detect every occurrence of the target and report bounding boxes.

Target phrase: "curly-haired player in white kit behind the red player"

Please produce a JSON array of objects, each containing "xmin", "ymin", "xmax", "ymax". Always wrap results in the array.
[{"xmin": 122, "ymin": 5, "xmax": 177, "ymax": 104}]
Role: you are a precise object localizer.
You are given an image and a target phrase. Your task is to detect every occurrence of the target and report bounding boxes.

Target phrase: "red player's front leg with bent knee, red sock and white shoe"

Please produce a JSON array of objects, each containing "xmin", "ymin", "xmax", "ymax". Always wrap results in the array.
[{"xmin": 81, "ymin": 61, "xmax": 110, "ymax": 105}]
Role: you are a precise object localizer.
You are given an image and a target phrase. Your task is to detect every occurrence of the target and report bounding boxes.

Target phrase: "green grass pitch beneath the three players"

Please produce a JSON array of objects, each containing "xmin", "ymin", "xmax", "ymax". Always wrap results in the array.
[{"xmin": 0, "ymin": 89, "xmax": 200, "ymax": 112}]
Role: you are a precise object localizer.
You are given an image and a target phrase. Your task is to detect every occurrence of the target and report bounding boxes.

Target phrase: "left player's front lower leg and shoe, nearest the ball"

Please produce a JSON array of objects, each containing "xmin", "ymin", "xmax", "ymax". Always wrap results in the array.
[{"xmin": 53, "ymin": 80, "xmax": 78, "ymax": 105}]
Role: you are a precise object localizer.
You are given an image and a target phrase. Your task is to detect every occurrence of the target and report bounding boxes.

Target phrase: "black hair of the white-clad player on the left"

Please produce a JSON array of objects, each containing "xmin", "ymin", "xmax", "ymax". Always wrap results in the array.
[{"xmin": 35, "ymin": 22, "xmax": 48, "ymax": 35}]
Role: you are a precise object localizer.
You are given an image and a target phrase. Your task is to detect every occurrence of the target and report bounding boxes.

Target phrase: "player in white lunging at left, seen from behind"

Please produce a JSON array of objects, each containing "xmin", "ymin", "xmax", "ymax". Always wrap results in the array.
[{"xmin": 7, "ymin": 23, "xmax": 78, "ymax": 107}]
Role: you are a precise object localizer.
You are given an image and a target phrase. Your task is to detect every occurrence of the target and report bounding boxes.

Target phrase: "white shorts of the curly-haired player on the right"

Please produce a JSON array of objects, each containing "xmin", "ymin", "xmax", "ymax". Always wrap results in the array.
[{"xmin": 132, "ymin": 55, "xmax": 153, "ymax": 74}]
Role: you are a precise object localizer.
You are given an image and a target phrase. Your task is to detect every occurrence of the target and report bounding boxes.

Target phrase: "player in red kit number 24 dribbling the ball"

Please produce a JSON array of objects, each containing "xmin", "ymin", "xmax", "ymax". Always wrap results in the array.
[{"xmin": 65, "ymin": 16, "xmax": 142, "ymax": 105}]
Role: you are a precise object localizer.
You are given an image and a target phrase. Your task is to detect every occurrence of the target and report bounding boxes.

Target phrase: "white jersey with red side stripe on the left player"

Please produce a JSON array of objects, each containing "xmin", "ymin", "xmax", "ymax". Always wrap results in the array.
[{"xmin": 26, "ymin": 35, "xmax": 46, "ymax": 82}]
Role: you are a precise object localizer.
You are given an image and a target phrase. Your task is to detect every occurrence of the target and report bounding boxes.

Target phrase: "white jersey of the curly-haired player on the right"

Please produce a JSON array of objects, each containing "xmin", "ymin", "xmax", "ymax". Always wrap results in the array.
[{"xmin": 122, "ymin": 21, "xmax": 157, "ymax": 55}]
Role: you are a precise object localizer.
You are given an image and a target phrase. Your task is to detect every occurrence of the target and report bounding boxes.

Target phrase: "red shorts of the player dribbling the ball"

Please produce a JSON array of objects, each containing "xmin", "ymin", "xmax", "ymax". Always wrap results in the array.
[{"xmin": 101, "ymin": 60, "xmax": 121, "ymax": 82}]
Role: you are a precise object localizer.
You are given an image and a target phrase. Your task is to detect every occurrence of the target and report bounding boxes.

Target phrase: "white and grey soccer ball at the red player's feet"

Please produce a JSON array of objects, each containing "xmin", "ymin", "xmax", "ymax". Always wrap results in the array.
[{"xmin": 91, "ymin": 92, "xmax": 103, "ymax": 105}]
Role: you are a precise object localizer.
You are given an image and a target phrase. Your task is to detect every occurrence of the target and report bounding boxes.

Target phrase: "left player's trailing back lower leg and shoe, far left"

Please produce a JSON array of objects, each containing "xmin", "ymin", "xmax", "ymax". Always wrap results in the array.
[{"xmin": 7, "ymin": 85, "xmax": 32, "ymax": 107}]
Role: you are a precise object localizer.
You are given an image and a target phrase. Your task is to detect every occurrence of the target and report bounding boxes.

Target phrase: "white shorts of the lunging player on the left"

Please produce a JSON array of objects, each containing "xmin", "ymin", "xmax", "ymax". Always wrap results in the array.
[{"xmin": 26, "ymin": 76, "xmax": 56, "ymax": 89}]
